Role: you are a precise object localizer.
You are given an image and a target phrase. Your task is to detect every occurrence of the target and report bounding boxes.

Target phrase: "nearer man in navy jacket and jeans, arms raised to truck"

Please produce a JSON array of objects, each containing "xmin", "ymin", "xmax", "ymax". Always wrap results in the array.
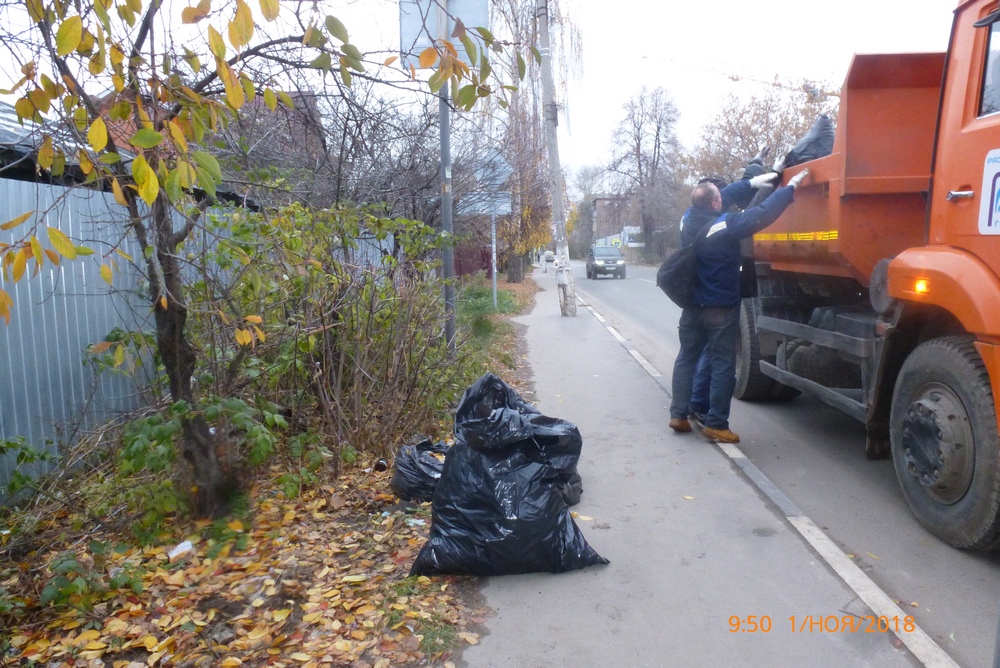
[{"xmin": 670, "ymin": 169, "xmax": 809, "ymax": 443}]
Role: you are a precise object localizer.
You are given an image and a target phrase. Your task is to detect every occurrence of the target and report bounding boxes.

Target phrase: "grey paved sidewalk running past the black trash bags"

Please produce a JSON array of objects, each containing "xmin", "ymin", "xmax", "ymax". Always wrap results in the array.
[{"xmin": 462, "ymin": 271, "xmax": 919, "ymax": 668}]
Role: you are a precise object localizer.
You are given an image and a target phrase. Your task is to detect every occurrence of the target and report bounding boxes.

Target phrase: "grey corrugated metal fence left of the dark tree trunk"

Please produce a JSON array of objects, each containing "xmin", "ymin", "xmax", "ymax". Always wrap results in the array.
[{"xmin": 0, "ymin": 179, "xmax": 148, "ymax": 484}]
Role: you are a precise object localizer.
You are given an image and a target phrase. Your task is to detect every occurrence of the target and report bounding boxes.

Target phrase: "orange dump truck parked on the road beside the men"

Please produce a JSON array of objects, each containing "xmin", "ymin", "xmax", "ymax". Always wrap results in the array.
[{"xmin": 736, "ymin": 0, "xmax": 1000, "ymax": 549}]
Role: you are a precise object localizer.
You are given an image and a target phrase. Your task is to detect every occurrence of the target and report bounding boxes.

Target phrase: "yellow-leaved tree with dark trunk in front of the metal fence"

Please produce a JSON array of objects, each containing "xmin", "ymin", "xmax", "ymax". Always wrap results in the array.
[{"xmin": 0, "ymin": 0, "xmax": 532, "ymax": 516}]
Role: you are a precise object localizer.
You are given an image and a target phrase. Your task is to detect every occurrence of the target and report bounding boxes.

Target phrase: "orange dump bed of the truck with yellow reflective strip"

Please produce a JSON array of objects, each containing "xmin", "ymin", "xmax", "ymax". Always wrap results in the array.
[{"xmin": 754, "ymin": 53, "xmax": 945, "ymax": 286}]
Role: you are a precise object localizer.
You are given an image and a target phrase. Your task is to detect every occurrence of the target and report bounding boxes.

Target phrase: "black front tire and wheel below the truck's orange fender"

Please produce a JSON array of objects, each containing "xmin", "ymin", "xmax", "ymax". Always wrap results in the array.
[{"xmin": 889, "ymin": 336, "xmax": 1000, "ymax": 550}]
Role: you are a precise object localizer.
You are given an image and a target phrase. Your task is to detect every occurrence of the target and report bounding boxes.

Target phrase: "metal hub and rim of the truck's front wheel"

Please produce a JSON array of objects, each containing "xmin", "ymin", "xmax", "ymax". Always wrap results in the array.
[{"xmin": 903, "ymin": 384, "xmax": 975, "ymax": 505}]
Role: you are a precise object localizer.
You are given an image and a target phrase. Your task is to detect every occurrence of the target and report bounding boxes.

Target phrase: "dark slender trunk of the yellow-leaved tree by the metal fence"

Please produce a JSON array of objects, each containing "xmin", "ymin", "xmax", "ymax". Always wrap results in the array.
[{"xmin": 148, "ymin": 196, "xmax": 237, "ymax": 517}]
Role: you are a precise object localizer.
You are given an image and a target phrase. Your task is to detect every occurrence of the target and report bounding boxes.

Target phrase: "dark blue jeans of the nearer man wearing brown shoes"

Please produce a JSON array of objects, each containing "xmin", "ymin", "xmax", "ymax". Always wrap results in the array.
[{"xmin": 670, "ymin": 305, "xmax": 740, "ymax": 429}]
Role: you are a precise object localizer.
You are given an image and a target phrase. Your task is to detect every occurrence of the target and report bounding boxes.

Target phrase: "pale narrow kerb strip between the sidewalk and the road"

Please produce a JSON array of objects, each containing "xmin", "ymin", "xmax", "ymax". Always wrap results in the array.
[{"xmin": 577, "ymin": 295, "xmax": 958, "ymax": 668}]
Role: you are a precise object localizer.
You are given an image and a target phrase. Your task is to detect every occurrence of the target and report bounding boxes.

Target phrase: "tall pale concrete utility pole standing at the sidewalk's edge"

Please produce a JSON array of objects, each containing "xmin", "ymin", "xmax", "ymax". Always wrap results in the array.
[{"xmin": 535, "ymin": 0, "xmax": 576, "ymax": 317}]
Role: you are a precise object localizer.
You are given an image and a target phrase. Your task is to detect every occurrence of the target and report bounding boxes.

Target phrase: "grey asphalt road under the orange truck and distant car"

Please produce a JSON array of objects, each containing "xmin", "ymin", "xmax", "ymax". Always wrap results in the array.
[{"xmin": 572, "ymin": 262, "xmax": 1000, "ymax": 666}]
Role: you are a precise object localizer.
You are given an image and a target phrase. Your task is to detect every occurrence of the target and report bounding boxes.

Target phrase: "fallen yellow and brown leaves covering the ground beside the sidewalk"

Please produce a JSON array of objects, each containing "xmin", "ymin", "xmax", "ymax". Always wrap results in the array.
[{"xmin": 0, "ymin": 278, "xmax": 544, "ymax": 668}]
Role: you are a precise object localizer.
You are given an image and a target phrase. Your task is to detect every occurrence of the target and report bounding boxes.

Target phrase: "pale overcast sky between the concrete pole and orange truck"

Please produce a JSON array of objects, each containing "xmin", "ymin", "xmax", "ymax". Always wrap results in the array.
[{"xmin": 559, "ymin": 0, "xmax": 959, "ymax": 168}]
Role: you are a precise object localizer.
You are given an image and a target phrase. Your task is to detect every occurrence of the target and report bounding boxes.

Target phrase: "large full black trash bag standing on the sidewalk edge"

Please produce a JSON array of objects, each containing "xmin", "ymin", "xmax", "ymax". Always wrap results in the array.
[{"xmin": 410, "ymin": 374, "xmax": 609, "ymax": 575}]
